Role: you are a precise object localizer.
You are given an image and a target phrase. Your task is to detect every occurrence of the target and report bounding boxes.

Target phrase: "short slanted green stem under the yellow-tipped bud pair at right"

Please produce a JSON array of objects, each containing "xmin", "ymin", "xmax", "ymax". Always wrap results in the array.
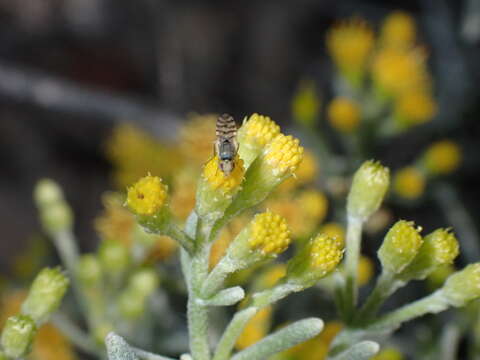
[{"xmin": 355, "ymin": 270, "xmax": 405, "ymax": 324}]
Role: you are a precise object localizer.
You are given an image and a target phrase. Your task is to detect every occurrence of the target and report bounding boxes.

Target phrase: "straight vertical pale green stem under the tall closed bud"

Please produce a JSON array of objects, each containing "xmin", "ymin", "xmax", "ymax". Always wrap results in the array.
[{"xmin": 343, "ymin": 216, "xmax": 363, "ymax": 321}]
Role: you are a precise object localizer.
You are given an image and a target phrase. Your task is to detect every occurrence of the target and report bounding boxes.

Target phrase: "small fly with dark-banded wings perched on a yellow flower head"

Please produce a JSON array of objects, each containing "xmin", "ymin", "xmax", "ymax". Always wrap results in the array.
[{"xmin": 215, "ymin": 114, "xmax": 238, "ymax": 176}]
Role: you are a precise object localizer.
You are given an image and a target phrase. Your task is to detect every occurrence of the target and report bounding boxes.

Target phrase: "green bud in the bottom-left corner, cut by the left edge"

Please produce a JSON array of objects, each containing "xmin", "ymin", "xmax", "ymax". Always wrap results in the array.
[{"xmin": 1, "ymin": 315, "xmax": 37, "ymax": 359}]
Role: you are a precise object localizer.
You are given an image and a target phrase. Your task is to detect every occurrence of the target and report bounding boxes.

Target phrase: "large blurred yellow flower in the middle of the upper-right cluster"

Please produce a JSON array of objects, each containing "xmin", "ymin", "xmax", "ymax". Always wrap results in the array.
[{"xmin": 372, "ymin": 48, "xmax": 430, "ymax": 96}]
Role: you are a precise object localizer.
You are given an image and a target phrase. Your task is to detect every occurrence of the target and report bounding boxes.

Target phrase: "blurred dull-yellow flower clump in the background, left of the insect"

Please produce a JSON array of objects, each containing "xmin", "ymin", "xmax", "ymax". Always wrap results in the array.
[{"xmin": 106, "ymin": 123, "xmax": 182, "ymax": 189}]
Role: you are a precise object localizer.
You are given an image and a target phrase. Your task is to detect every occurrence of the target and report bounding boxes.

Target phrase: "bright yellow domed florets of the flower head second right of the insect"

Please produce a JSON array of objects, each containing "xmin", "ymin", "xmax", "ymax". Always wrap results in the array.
[{"xmin": 264, "ymin": 134, "xmax": 303, "ymax": 176}]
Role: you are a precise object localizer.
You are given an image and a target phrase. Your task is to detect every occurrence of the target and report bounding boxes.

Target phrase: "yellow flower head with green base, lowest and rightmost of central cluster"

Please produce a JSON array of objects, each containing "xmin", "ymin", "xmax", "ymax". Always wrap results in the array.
[{"xmin": 287, "ymin": 234, "xmax": 343, "ymax": 287}]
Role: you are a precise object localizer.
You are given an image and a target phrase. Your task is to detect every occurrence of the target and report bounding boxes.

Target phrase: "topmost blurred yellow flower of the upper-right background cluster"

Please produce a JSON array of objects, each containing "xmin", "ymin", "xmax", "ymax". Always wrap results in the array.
[{"xmin": 380, "ymin": 11, "xmax": 417, "ymax": 48}]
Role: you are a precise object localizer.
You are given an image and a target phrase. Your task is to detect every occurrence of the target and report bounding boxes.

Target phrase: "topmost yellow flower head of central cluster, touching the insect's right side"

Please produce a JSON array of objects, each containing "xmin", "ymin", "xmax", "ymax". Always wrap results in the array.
[{"xmin": 237, "ymin": 114, "xmax": 280, "ymax": 168}]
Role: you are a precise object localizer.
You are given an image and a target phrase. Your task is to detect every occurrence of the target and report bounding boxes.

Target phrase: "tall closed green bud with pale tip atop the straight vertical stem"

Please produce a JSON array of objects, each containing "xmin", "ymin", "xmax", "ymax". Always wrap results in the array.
[{"xmin": 347, "ymin": 160, "xmax": 390, "ymax": 221}]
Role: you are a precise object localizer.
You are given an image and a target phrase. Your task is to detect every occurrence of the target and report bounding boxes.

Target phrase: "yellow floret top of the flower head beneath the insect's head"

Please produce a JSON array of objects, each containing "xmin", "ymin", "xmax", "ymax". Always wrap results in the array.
[{"xmin": 203, "ymin": 155, "xmax": 245, "ymax": 194}]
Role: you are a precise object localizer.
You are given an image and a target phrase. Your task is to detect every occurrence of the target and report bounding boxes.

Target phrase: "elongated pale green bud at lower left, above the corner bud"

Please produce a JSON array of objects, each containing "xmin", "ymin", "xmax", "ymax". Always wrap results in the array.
[{"xmin": 22, "ymin": 267, "xmax": 69, "ymax": 324}]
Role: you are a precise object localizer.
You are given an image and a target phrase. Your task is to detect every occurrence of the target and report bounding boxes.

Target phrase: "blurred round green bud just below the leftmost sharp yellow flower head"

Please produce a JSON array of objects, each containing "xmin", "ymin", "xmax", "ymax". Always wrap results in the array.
[{"xmin": 98, "ymin": 240, "xmax": 130, "ymax": 277}]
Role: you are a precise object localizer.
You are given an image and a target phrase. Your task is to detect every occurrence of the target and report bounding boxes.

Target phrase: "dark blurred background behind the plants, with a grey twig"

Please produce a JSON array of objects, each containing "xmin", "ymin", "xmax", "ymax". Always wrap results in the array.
[{"xmin": 0, "ymin": 0, "xmax": 480, "ymax": 270}]
